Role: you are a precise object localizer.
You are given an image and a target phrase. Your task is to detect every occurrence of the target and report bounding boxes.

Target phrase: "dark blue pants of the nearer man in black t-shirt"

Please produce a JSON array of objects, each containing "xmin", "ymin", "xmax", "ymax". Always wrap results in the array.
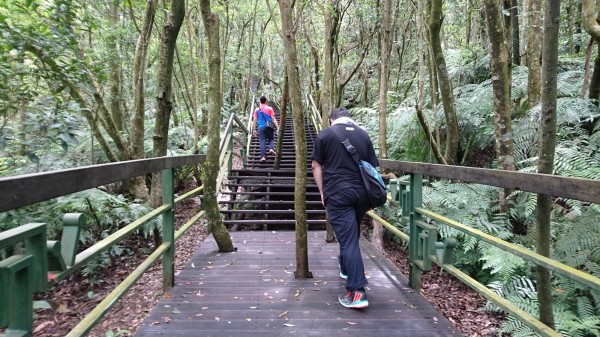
[{"xmin": 326, "ymin": 186, "xmax": 369, "ymax": 291}]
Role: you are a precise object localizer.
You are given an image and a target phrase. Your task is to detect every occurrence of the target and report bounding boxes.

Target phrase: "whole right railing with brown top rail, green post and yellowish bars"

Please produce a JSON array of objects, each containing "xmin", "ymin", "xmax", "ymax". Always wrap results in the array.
[{"xmin": 368, "ymin": 159, "xmax": 600, "ymax": 336}]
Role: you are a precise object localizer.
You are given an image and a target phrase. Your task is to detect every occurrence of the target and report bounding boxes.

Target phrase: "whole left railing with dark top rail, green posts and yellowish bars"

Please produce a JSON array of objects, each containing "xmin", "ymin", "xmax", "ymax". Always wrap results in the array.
[{"xmin": 0, "ymin": 155, "xmax": 204, "ymax": 336}]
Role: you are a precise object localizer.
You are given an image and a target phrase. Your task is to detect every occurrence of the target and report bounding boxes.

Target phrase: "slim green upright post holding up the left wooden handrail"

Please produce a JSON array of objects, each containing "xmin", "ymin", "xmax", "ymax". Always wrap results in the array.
[{"xmin": 162, "ymin": 169, "xmax": 175, "ymax": 291}]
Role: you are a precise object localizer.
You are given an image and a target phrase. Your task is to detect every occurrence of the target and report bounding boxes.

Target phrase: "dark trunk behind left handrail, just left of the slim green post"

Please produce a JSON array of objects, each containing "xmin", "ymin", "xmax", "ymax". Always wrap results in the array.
[{"xmin": 150, "ymin": 0, "xmax": 185, "ymax": 207}]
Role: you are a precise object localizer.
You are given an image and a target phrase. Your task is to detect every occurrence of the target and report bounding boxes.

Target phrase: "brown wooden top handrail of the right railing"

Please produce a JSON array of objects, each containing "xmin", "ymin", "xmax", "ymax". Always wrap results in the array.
[{"xmin": 379, "ymin": 159, "xmax": 600, "ymax": 204}]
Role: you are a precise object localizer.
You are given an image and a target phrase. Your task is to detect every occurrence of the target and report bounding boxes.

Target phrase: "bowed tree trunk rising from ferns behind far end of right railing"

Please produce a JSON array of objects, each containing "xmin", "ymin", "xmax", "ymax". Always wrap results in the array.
[{"xmin": 429, "ymin": 0, "xmax": 459, "ymax": 165}]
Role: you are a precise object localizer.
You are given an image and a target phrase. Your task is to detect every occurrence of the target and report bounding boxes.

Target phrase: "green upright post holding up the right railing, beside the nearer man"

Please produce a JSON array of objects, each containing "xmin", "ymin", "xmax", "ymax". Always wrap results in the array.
[{"xmin": 408, "ymin": 173, "xmax": 423, "ymax": 290}]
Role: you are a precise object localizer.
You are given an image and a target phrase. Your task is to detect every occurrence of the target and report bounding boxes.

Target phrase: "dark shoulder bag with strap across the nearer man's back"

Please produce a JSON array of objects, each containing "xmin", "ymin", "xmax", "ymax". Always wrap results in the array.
[{"xmin": 331, "ymin": 125, "xmax": 387, "ymax": 208}]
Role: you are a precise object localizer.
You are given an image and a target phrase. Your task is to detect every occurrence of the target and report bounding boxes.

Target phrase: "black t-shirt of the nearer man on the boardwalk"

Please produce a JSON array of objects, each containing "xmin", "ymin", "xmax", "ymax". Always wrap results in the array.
[{"xmin": 311, "ymin": 123, "xmax": 379, "ymax": 200}]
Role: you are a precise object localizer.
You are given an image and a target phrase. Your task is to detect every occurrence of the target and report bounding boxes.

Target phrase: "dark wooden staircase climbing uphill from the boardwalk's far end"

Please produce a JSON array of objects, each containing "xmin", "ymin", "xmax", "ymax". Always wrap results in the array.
[{"xmin": 219, "ymin": 109, "xmax": 326, "ymax": 230}]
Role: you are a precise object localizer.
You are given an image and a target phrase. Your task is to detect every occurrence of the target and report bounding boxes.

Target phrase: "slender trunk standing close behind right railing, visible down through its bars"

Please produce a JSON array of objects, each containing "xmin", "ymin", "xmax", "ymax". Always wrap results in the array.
[{"xmin": 536, "ymin": 0, "xmax": 560, "ymax": 329}]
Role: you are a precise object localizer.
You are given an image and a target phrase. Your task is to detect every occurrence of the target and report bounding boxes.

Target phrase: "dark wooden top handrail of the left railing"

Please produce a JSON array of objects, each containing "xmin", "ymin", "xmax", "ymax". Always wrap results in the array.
[{"xmin": 0, "ymin": 155, "xmax": 205, "ymax": 212}]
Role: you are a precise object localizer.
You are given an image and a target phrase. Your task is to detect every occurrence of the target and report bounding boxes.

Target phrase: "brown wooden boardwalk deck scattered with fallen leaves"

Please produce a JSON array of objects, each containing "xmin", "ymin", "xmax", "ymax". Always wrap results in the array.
[{"xmin": 135, "ymin": 231, "xmax": 460, "ymax": 337}]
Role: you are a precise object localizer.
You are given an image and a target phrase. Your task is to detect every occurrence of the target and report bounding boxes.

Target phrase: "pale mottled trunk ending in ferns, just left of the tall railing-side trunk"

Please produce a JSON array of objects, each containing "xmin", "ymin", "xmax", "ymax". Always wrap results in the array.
[{"xmin": 527, "ymin": 0, "xmax": 542, "ymax": 108}]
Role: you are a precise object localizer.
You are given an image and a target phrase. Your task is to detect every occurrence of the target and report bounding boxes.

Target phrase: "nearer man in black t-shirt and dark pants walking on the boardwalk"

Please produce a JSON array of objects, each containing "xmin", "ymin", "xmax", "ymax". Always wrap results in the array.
[{"xmin": 311, "ymin": 108, "xmax": 379, "ymax": 308}]
